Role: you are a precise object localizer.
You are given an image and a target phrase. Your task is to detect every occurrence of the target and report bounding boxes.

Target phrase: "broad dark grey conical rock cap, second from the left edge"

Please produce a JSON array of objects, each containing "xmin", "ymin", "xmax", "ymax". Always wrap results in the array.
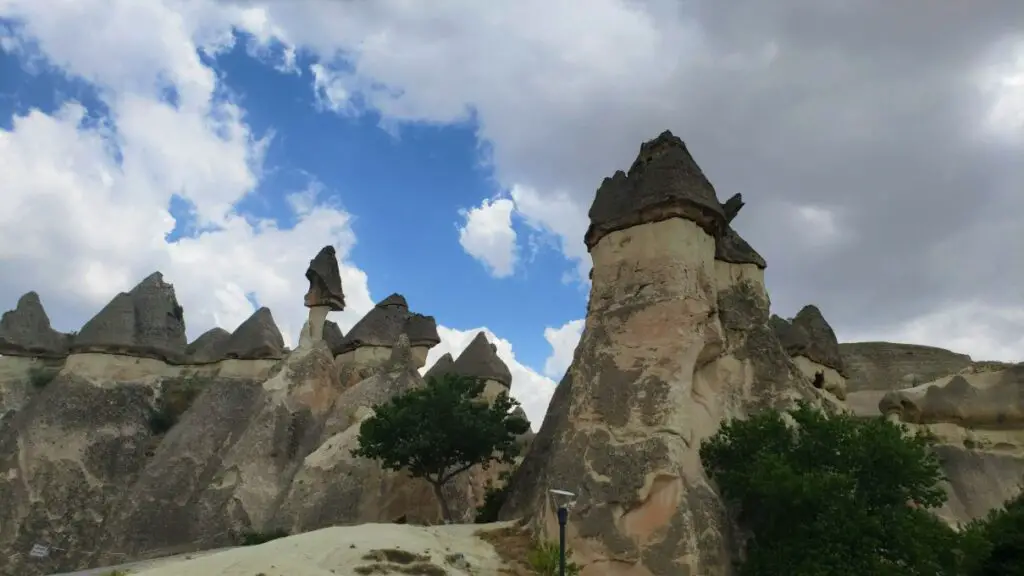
[{"xmin": 72, "ymin": 272, "xmax": 187, "ymax": 362}]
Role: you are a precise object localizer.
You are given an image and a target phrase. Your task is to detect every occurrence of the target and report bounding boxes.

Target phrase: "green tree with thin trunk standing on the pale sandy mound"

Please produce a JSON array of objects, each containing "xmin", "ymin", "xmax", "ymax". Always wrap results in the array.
[{"xmin": 352, "ymin": 374, "xmax": 529, "ymax": 523}]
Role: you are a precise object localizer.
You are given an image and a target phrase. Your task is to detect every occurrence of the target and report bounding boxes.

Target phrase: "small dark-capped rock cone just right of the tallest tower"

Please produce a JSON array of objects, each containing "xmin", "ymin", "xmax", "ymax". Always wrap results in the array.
[{"xmin": 769, "ymin": 305, "xmax": 846, "ymax": 400}]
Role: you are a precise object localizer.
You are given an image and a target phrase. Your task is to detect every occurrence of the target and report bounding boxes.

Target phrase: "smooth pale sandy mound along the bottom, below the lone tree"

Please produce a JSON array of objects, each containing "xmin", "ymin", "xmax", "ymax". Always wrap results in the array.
[{"xmin": 88, "ymin": 523, "xmax": 511, "ymax": 576}]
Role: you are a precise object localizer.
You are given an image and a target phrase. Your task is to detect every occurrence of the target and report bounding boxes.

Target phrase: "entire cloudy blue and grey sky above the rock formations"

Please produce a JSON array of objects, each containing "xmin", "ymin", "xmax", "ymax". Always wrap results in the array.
[{"xmin": 0, "ymin": 0, "xmax": 1024, "ymax": 426}]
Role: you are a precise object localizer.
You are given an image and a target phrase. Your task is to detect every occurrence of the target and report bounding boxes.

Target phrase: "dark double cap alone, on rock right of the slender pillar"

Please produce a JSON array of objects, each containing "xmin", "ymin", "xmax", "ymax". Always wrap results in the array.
[{"xmin": 339, "ymin": 294, "xmax": 440, "ymax": 354}]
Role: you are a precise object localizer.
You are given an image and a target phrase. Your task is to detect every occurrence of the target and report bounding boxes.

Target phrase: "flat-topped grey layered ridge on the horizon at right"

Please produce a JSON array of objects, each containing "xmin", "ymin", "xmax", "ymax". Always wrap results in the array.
[{"xmin": 839, "ymin": 342, "xmax": 972, "ymax": 393}]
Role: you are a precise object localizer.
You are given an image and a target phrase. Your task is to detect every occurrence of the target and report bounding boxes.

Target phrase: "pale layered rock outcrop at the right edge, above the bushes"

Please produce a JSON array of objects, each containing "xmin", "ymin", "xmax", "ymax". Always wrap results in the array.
[{"xmin": 879, "ymin": 364, "xmax": 1024, "ymax": 524}]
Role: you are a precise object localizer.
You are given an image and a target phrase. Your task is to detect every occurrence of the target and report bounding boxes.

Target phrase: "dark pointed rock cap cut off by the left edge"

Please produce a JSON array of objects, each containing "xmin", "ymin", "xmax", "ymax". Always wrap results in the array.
[{"xmin": 0, "ymin": 292, "xmax": 71, "ymax": 358}]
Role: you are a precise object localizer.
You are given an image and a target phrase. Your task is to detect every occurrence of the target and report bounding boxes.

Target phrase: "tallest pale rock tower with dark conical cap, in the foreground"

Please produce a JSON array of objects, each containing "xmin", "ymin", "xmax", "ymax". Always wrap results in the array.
[{"xmin": 502, "ymin": 132, "xmax": 817, "ymax": 576}]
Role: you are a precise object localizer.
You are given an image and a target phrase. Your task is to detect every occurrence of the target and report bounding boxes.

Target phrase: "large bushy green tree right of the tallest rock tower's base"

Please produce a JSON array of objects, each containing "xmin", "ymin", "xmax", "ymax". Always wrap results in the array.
[{"xmin": 700, "ymin": 404, "xmax": 962, "ymax": 576}]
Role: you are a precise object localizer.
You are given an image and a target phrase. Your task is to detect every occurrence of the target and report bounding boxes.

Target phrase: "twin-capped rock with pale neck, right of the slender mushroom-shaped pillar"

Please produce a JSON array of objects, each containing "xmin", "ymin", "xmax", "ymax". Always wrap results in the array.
[{"xmin": 338, "ymin": 294, "xmax": 440, "ymax": 368}]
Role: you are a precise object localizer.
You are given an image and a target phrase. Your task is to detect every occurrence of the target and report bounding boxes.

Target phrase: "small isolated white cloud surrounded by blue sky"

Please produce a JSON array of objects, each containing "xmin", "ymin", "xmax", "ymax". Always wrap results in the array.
[{"xmin": 459, "ymin": 198, "xmax": 519, "ymax": 278}]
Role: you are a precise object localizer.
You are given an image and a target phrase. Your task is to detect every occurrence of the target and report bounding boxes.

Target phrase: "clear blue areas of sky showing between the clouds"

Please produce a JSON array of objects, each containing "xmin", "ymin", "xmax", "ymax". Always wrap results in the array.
[{"xmin": 0, "ymin": 28, "xmax": 586, "ymax": 368}]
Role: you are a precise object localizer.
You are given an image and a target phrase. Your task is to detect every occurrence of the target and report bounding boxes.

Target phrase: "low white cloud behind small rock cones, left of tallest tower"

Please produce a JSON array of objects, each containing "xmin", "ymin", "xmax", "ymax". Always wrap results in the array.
[{"xmin": 420, "ymin": 326, "xmax": 555, "ymax": 430}]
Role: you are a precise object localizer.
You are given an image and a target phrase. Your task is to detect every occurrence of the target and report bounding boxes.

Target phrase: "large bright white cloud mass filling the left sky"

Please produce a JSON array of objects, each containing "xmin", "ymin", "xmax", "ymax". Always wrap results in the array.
[{"xmin": 0, "ymin": 0, "xmax": 372, "ymax": 341}]
